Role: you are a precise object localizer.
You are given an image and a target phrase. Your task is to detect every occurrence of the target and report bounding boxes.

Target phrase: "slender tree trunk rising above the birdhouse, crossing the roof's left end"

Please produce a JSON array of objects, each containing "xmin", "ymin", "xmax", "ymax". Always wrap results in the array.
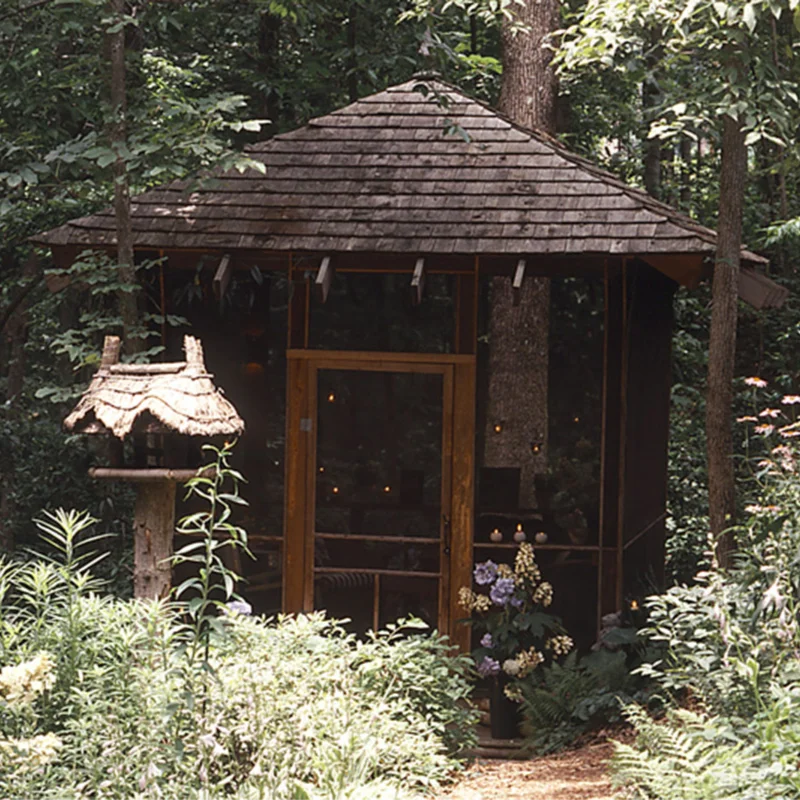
[{"xmin": 107, "ymin": 0, "xmax": 138, "ymax": 352}]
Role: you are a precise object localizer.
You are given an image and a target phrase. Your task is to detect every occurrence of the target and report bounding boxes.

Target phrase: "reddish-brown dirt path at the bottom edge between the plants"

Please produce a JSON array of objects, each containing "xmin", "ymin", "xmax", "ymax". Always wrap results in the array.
[{"xmin": 438, "ymin": 742, "xmax": 615, "ymax": 800}]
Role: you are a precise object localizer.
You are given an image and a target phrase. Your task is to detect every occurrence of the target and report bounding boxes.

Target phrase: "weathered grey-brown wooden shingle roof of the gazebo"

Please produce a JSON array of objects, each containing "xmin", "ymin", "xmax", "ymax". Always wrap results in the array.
[{"xmin": 35, "ymin": 80, "xmax": 765, "ymax": 262}]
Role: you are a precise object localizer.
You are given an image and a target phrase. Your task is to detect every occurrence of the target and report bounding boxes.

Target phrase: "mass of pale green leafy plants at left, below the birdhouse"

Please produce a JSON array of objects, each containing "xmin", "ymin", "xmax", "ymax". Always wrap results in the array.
[{"xmin": 0, "ymin": 440, "xmax": 474, "ymax": 800}]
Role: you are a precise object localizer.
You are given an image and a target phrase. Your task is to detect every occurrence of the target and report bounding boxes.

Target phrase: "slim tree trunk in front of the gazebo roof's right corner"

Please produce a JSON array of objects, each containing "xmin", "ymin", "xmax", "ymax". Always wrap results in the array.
[{"xmin": 706, "ymin": 116, "xmax": 747, "ymax": 566}]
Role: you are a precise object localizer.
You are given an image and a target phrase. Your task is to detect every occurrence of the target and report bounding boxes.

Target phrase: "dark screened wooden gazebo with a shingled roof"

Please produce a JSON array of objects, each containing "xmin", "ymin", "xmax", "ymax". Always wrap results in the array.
[{"xmin": 32, "ymin": 80, "xmax": 784, "ymax": 642}]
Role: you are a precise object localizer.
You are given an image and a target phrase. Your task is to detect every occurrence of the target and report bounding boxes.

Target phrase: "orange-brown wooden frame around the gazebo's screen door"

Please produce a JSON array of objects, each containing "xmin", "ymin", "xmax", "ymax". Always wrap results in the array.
[{"xmin": 283, "ymin": 350, "xmax": 476, "ymax": 651}]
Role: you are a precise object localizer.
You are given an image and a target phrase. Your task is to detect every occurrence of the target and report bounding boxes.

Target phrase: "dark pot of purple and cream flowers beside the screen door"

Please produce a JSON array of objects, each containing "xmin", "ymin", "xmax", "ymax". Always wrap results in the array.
[{"xmin": 459, "ymin": 542, "xmax": 573, "ymax": 739}]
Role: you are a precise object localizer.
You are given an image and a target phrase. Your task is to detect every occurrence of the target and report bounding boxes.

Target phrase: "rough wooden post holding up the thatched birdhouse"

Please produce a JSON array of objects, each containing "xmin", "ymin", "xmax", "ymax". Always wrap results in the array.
[{"xmin": 133, "ymin": 481, "xmax": 175, "ymax": 600}]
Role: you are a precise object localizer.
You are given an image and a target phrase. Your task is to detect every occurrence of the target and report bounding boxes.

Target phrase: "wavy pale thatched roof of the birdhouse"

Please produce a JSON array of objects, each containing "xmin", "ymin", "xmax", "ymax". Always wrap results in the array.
[{"xmin": 64, "ymin": 336, "xmax": 244, "ymax": 439}]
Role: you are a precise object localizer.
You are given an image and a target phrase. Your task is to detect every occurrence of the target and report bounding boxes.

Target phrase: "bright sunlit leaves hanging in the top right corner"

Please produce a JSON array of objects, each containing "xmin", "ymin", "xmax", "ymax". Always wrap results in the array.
[{"xmin": 558, "ymin": 0, "xmax": 797, "ymax": 144}]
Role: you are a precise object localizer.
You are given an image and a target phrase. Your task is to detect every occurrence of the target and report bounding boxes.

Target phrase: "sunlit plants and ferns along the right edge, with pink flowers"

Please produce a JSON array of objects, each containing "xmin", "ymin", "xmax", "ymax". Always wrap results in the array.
[{"xmin": 615, "ymin": 378, "xmax": 800, "ymax": 800}]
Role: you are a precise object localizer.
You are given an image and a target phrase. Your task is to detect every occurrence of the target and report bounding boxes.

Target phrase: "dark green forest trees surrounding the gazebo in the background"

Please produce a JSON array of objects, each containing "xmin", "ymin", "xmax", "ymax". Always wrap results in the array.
[{"xmin": 0, "ymin": 0, "xmax": 800, "ymax": 586}]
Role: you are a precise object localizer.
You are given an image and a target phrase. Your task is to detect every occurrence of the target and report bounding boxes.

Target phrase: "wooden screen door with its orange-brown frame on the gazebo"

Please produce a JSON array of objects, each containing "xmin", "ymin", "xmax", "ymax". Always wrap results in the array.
[{"xmin": 284, "ymin": 350, "xmax": 475, "ymax": 646}]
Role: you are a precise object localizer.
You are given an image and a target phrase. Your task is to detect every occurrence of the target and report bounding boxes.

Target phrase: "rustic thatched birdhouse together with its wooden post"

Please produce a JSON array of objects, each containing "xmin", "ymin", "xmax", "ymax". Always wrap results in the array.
[{"xmin": 64, "ymin": 336, "xmax": 244, "ymax": 598}]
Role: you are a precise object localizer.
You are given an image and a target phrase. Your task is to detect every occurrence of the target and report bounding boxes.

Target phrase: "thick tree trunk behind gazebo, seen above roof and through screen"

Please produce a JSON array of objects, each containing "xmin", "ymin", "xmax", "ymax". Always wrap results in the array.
[{"xmin": 483, "ymin": 0, "xmax": 559, "ymax": 508}]
